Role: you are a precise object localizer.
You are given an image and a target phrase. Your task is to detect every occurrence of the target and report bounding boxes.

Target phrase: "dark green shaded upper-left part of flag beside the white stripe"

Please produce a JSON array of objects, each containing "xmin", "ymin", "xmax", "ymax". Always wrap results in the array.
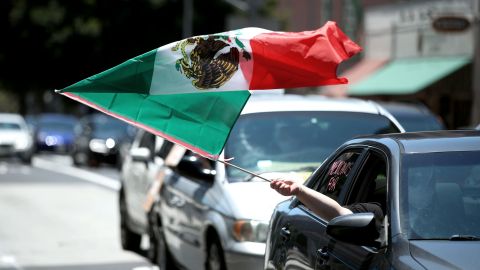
[{"xmin": 61, "ymin": 49, "xmax": 157, "ymax": 94}]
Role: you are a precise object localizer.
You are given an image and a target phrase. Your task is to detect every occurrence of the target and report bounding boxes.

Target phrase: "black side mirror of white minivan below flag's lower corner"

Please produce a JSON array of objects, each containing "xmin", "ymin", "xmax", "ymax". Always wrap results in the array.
[{"xmin": 176, "ymin": 155, "xmax": 216, "ymax": 182}]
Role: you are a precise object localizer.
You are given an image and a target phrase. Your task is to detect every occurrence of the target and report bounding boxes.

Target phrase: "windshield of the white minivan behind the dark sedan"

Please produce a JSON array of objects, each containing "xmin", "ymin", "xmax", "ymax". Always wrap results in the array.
[{"xmin": 225, "ymin": 111, "xmax": 398, "ymax": 181}]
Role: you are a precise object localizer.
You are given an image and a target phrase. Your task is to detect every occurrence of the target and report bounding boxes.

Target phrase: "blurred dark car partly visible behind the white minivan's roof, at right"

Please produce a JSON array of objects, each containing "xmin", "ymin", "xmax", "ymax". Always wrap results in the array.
[{"xmin": 378, "ymin": 102, "xmax": 446, "ymax": 132}]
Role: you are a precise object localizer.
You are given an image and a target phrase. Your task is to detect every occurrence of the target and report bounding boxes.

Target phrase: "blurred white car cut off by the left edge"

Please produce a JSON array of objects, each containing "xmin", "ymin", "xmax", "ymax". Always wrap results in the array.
[{"xmin": 0, "ymin": 113, "xmax": 33, "ymax": 164}]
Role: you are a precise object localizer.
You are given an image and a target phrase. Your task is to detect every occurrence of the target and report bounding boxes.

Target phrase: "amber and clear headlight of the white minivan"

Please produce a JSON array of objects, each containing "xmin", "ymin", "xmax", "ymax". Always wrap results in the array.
[{"xmin": 232, "ymin": 220, "xmax": 268, "ymax": 243}]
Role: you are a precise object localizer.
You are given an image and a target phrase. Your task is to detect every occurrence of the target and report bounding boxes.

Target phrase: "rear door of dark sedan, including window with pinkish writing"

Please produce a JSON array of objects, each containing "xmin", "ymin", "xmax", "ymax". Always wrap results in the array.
[{"xmin": 280, "ymin": 148, "xmax": 362, "ymax": 269}]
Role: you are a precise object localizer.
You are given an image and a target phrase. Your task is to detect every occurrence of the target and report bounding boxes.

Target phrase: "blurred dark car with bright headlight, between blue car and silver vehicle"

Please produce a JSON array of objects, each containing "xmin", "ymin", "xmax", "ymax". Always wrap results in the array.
[{"xmin": 72, "ymin": 113, "xmax": 135, "ymax": 168}]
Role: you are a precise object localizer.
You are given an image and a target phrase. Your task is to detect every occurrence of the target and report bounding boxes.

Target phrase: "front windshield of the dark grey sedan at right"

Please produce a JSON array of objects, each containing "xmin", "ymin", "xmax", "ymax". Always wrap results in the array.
[{"xmin": 400, "ymin": 151, "xmax": 480, "ymax": 240}]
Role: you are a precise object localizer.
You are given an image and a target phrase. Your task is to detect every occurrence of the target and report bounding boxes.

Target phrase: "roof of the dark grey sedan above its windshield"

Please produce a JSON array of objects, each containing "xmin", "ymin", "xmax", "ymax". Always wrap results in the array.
[{"xmin": 352, "ymin": 130, "xmax": 480, "ymax": 154}]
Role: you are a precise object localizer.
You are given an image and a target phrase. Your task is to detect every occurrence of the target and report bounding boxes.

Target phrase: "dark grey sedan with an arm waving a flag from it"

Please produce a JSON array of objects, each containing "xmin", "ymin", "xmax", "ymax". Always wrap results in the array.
[{"xmin": 264, "ymin": 131, "xmax": 480, "ymax": 269}]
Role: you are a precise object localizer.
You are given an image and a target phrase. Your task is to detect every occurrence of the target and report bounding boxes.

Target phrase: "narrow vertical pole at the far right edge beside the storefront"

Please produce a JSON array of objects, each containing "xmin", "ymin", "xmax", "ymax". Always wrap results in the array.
[{"xmin": 470, "ymin": 0, "xmax": 480, "ymax": 125}]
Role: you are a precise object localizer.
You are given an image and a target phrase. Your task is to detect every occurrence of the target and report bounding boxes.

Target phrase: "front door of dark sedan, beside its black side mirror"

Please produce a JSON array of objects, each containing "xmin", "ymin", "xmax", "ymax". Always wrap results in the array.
[{"xmin": 322, "ymin": 148, "xmax": 390, "ymax": 269}]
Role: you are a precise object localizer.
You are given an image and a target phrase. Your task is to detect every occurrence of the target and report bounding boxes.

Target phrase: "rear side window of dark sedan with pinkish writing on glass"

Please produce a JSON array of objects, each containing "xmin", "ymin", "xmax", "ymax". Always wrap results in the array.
[{"xmin": 317, "ymin": 149, "xmax": 360, "ymax": 200}]
